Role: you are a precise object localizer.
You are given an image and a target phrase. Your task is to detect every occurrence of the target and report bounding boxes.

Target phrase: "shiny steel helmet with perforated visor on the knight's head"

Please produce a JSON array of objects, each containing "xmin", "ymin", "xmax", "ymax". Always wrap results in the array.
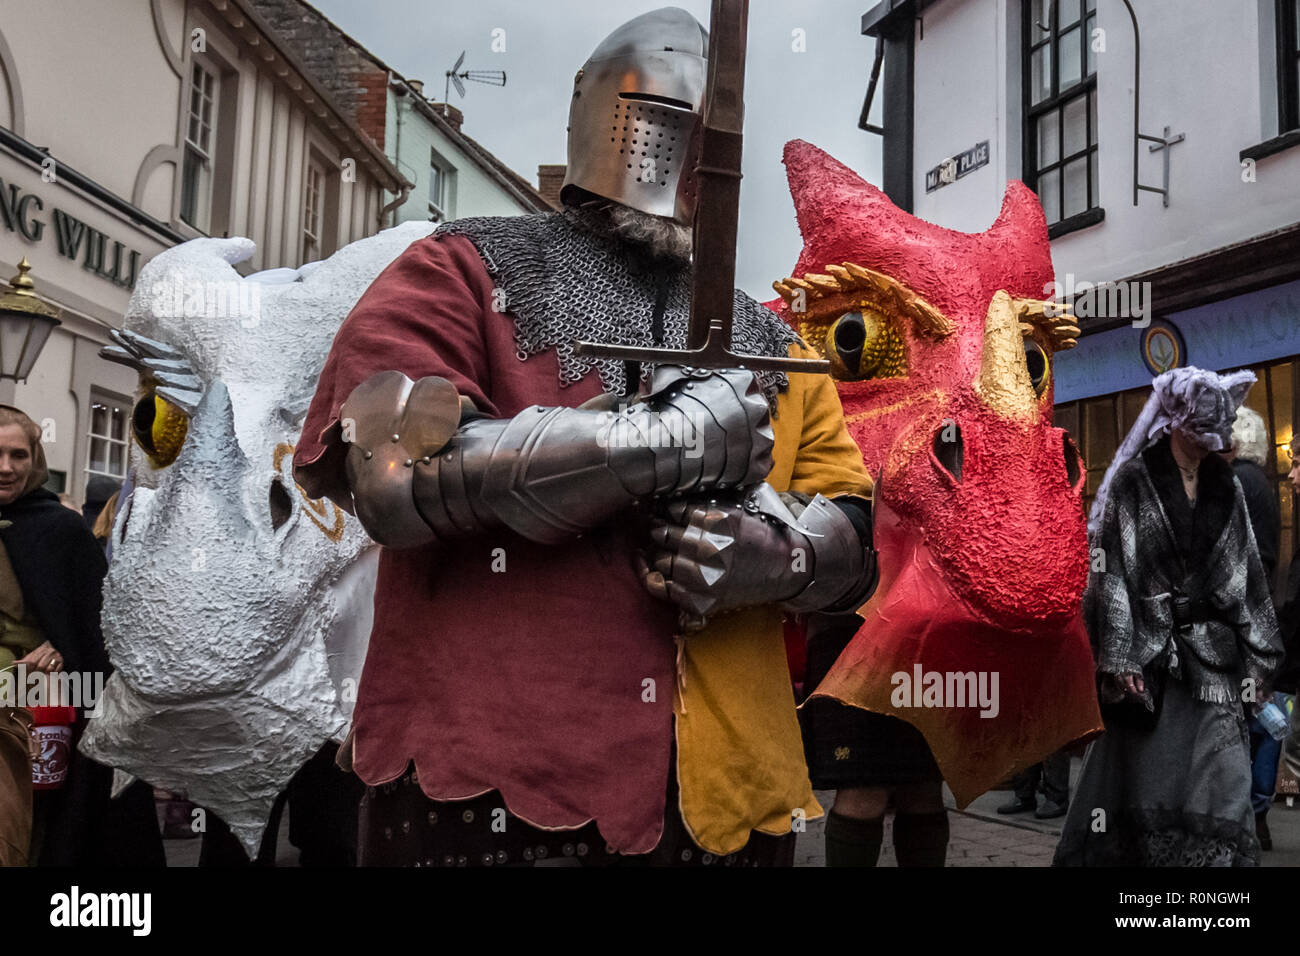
[{"xmin": 560, "ymin": 7, "xmax": 709, "ymax": 225}]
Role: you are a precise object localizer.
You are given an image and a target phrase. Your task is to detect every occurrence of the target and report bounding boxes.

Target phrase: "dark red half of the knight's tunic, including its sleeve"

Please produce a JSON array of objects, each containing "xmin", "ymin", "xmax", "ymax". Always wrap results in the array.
[{"xmin": 295, "ymin": 237, "xmax": 676, "ymax": 853}]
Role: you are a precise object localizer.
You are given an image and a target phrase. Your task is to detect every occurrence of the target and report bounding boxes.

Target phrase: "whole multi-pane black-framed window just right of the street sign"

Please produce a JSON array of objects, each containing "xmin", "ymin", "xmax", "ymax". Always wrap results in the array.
[{"xmin": 1022, "ymin": 0, "xmax": 1100, "ymax": 237}]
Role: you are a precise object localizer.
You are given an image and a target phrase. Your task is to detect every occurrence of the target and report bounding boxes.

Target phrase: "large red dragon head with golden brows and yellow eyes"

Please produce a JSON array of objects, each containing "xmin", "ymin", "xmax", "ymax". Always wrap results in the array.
[{"xmin": 772, "ymin": 140, "xmax": 1100, "ymax": 804}]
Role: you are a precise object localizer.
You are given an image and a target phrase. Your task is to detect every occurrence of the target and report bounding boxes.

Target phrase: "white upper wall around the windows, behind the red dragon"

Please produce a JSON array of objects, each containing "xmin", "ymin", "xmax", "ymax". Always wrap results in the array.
[{"xmin": 914, "ymin": 0, "xmax": 1300, "ymax": 283}]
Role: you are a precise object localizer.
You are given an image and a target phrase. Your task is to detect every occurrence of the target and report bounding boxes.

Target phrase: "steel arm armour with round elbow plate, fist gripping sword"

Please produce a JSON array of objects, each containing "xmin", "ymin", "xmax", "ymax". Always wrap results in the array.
[{"xmin": 341, "ymin": 367, "xmax": 772, "ymax": 548}]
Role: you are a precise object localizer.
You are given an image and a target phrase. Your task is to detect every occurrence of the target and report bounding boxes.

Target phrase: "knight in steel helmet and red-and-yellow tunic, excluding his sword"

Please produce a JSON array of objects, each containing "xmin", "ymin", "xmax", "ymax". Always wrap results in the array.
[{"xmin": 295, "ymin": 8, "xmax": 875, "ymax": 866}]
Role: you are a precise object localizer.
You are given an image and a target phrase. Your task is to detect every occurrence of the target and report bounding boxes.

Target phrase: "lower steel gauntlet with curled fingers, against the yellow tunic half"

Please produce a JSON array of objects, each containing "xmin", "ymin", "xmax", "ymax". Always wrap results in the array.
[{"xmin": 641, "ymin": 483, "xmax": 876, "ymax": 630}]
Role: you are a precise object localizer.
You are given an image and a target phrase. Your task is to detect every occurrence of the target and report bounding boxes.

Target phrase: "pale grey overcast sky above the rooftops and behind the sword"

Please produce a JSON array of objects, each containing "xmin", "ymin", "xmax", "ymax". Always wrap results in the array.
[{"xmin": 311, "ymin": 0, "xmax": 880, "ymax": 300}]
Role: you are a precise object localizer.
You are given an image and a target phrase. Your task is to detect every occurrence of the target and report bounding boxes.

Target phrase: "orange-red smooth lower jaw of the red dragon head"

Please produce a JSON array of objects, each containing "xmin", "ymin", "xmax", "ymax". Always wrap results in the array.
[{"xmin": 813, "ymin": 502, "xmax": 1101, "ymax": 808}]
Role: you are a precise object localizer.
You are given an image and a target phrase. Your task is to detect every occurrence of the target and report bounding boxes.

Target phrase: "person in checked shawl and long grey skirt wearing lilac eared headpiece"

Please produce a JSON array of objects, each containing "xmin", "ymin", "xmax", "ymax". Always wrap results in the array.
[{"xmin": 1054, "ymin": 368, "xmax": 1282, "ymax": 866}]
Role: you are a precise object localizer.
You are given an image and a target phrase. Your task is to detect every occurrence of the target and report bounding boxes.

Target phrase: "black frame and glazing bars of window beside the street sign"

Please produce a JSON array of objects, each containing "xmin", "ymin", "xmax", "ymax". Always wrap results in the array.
[{"xmin": 1021, "ymin": 0, "xmax": 1105, "ymax": 231}]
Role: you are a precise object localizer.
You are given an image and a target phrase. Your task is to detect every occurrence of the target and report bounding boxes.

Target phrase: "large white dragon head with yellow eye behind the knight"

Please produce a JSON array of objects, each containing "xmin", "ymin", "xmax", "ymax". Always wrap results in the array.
[{"xmin": 82, "ymin": 222, "xmax": 432, "ymax": 851}]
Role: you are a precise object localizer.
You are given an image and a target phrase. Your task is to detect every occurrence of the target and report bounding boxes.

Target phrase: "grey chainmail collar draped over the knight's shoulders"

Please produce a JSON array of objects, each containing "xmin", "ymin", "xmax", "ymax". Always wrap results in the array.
[{"xmin": 434, "ymin": 209, "xmax": 797, "ymax": 408}]
